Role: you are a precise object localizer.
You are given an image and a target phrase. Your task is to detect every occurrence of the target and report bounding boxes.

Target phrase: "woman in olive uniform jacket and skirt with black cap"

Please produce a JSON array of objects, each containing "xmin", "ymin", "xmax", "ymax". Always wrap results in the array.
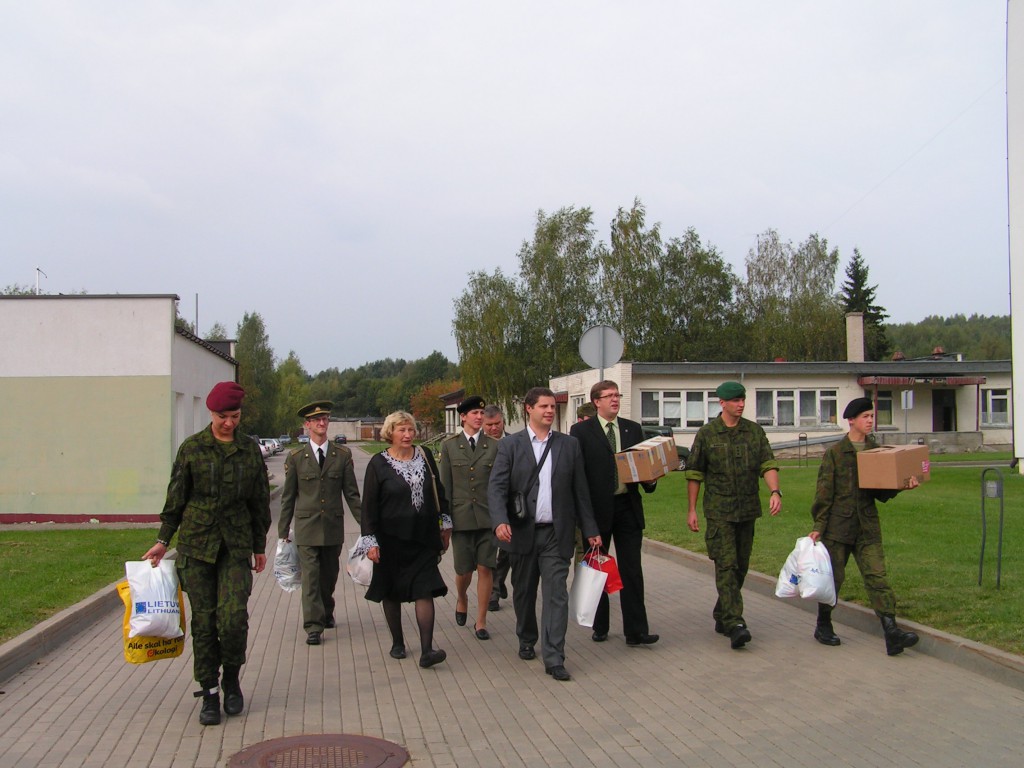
[{"xmin": 437, "ymin": 395, "xmax": 498, "ymax": 640}]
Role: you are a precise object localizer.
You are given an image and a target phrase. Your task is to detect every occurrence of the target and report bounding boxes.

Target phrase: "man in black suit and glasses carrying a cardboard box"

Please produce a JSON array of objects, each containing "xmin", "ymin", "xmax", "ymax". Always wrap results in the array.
[{"xmin": 569, "ymin": 380, "xmax": 658, "ymax": 645}]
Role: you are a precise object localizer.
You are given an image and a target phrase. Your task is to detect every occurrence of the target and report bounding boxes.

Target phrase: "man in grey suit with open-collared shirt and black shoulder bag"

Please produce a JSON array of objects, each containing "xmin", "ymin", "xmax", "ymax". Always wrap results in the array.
[{"xmin": 487, "ymin": 387, "xmax": 601, "ymax": 682}]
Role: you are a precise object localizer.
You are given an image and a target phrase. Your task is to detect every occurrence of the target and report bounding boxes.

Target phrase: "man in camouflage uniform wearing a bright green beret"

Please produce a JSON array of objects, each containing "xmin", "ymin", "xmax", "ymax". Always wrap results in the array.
[{"xmin": 686, "ymin": 381, "xmax": 782, "ymax": 648}]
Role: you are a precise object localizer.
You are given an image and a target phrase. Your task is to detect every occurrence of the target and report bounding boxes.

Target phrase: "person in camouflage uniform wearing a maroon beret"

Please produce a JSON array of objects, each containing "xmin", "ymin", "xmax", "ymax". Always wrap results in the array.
[{"xmin": 142, "ymin": 381, "xmax": 270, "ymax": 725}]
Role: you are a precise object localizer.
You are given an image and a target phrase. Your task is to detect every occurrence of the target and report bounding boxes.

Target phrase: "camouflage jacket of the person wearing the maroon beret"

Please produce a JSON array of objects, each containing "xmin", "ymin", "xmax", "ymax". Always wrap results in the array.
[{"xmin": 157, "ymin": 425, "xmax": 270, "ymax": 563}]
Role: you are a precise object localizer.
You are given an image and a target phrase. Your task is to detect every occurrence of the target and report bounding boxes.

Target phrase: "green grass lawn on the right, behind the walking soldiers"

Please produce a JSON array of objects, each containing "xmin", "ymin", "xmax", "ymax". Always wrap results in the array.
[{"xmin": 644, "ymin": 463, "xmax": 1024, "ymax": 654}]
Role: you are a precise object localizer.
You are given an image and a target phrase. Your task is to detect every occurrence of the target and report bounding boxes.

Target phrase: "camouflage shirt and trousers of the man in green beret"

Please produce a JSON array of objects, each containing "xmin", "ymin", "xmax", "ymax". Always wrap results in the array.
[{"xmin": 686, "ymin": 416, "xmax": 778, "ymax": 634}]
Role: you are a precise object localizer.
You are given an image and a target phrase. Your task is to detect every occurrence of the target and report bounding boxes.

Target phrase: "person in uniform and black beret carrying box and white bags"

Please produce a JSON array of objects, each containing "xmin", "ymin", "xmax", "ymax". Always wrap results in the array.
[{"xmin": 809, "ymin": 397, "xmax": 918, "ymax": 656}]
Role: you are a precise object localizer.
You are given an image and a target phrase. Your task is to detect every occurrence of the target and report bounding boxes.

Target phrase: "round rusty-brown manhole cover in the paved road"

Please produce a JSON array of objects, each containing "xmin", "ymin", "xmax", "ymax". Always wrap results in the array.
[{"xmin": 227, "ymin": 733, "xmax": 409, "ymax": 768}]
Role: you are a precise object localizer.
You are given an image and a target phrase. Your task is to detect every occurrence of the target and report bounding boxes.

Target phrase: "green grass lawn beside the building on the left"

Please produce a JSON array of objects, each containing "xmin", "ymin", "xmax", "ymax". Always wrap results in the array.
[{"xmin": 0, "ymin": 526, "xmax": 157, "ymax": 642}]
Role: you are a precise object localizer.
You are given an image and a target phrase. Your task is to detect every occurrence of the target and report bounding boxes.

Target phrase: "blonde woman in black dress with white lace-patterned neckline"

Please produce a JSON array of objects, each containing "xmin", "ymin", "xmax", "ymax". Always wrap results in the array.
[{"xmin": 360, "ymin": 411, "xmax": 452, "ymax": 668}]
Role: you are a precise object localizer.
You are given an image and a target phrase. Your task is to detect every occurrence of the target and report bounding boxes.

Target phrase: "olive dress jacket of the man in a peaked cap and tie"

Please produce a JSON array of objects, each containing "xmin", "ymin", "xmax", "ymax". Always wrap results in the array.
[{"xmin": 278, "ymin": 442, "xmax": 361, "ymax": 547}]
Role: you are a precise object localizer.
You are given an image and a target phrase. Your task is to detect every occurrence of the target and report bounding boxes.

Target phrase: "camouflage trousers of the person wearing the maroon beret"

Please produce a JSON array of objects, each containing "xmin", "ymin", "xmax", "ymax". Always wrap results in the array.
[{"xmin": 177, "ymin": 547, "xmax": 253, "ymax": 688}]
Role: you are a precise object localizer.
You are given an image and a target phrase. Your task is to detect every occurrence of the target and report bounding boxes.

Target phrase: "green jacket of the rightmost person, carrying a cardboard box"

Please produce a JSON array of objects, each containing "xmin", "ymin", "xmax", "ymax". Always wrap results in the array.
[{"xmin": 811, "ymin": 435, "xmax": 899, "ymax": 544}]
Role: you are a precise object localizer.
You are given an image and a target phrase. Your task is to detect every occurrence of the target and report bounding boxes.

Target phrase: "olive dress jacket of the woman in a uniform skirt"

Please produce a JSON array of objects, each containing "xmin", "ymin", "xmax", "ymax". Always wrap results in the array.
[{"xmin": 437, "ymin": 430, "xmax": 498, "ymax": 530}]
